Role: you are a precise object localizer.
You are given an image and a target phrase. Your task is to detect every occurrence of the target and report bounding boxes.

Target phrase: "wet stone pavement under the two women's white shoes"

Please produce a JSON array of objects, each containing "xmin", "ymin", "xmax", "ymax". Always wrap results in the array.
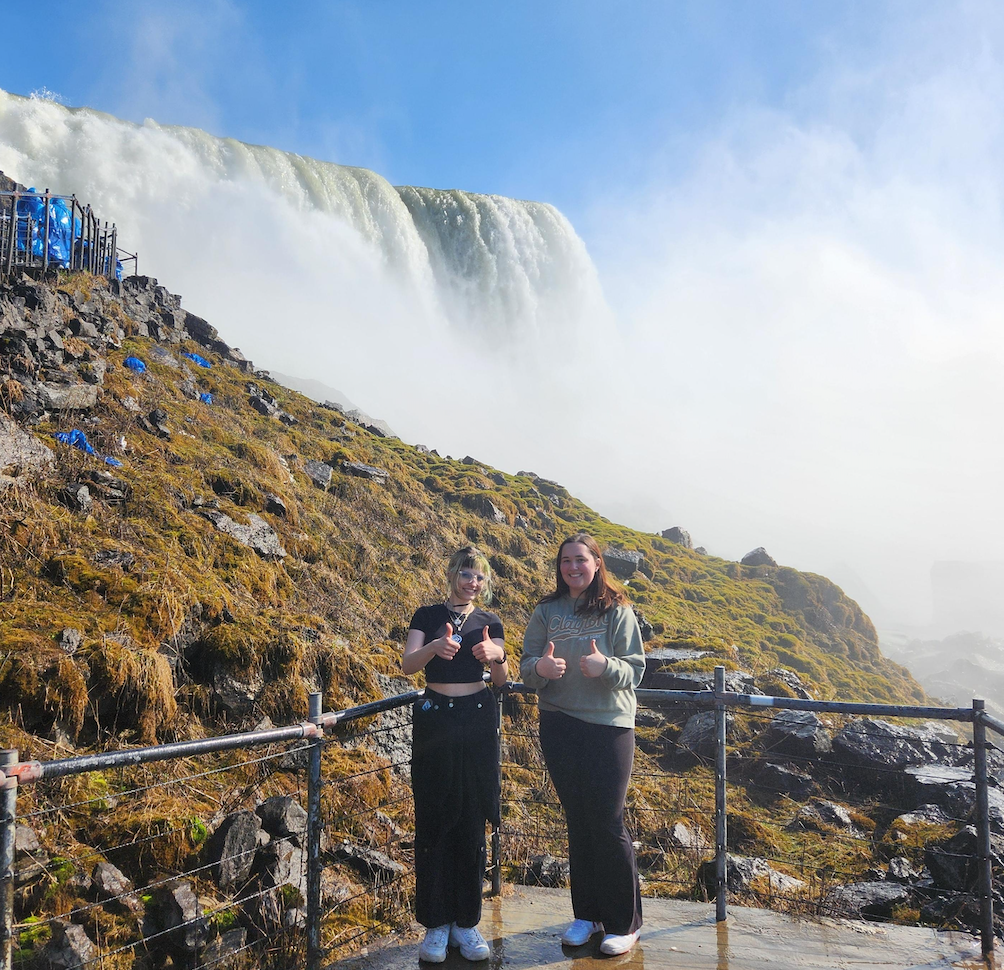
[{"xmin": 331, "ymin": 887, "xmax": 987, "ymax": 970}]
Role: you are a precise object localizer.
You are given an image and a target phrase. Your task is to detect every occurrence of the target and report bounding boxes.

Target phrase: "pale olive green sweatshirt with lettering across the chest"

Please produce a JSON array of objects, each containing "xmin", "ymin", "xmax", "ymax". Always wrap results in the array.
[{"xmin": 519, "ymin": 596, "xmax": 645, "ymax": 727}]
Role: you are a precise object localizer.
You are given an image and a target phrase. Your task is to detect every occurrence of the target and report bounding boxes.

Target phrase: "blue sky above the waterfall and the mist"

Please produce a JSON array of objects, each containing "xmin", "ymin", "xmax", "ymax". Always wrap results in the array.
[{"xmin": 0, "ymin": 0, "xmax": 895, "ymax": 222}]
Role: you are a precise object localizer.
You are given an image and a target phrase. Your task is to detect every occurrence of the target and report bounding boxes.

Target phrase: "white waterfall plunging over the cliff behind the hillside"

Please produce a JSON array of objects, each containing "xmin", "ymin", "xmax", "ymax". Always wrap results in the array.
[{"xmin": 0, "ymin": 85, "xmax": 612, "ymax": 483}]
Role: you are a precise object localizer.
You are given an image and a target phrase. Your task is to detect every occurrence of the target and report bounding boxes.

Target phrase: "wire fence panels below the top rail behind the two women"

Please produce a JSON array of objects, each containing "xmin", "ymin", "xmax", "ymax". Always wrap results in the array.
[{"xmin": 0, "ymin": 688, "xmax": 1004, "ymax": 970}]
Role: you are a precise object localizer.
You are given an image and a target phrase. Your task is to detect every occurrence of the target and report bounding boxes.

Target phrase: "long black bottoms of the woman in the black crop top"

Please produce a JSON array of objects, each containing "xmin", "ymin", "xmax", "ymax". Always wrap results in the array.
[{"xmin": 412, "ymin": 689, "xmax": 499, "ymax": 927}]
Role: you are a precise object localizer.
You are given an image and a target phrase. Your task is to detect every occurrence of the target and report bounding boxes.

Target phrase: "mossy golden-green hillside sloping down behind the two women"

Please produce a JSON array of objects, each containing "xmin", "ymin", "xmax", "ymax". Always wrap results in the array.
[{"xmin": 0, "ymin": 276, "xmax": 924, "ymax": 741}]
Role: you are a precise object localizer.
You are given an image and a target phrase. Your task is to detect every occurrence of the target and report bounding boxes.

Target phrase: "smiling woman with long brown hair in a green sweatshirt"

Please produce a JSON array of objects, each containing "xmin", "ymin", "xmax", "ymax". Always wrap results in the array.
[{"xmin": 520, "ymin": 532, "xmax": 645, "ymax": 955}]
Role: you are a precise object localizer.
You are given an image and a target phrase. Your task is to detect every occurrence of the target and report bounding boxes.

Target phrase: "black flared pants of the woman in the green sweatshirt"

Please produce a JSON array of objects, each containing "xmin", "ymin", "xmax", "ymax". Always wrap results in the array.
[{"xmin": 540, "ymin": 711, "xmax": 642, "ymax": 936}]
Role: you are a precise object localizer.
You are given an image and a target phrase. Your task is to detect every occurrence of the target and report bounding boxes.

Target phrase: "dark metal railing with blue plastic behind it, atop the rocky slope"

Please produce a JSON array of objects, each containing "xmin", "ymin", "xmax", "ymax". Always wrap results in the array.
[{"xmin": 0, "ymin": 189, "xmax": 140, "ymax": 279}]
